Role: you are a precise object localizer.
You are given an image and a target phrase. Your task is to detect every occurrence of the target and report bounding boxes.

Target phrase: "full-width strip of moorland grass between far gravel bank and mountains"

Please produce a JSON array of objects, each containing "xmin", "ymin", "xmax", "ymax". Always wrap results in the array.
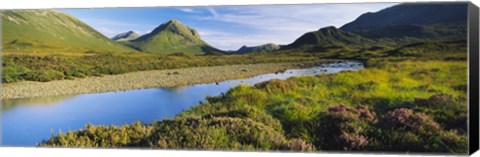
[{"xmin": 2, "ymin": 41, "xmax": 467, "ymax": 83}]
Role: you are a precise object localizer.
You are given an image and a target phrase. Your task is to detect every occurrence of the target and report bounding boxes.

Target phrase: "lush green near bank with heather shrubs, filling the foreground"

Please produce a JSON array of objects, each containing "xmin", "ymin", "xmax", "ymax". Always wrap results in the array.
[{"xmin": 40, "ymin": 60, "xmax": 468, "ymax": 153}]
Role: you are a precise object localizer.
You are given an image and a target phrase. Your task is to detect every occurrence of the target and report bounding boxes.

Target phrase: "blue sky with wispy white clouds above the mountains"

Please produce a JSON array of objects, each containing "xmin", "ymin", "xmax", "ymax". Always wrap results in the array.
[{"xmin": 60, "ymin": 3, "xmax": 396, "ymax": 50}]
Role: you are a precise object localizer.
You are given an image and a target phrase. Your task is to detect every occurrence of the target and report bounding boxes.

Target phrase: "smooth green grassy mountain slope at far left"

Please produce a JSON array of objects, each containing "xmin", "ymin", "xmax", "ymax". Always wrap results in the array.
[{"xmin": 0, "ymin": 10, "xmax": 136, "ymax": 53}]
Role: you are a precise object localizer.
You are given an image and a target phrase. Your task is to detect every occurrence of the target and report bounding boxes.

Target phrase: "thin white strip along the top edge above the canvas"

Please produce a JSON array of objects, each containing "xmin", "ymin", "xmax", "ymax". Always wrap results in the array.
[{"xmin": 0, "ymin": 0, "xmax": 472, "ymax": 9}]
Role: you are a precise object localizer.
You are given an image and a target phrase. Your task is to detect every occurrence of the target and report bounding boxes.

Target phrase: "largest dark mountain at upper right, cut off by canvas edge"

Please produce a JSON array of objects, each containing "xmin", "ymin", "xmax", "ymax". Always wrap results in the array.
[{"xmin": 340, "ymin": 2, "xmax": 468, "ymax": 40}]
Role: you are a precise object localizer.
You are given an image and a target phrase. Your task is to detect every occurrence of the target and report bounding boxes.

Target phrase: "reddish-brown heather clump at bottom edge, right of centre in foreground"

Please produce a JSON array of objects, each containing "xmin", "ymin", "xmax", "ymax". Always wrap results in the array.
[{"xmin": 311, "ymin": 105, "xmax": 376, "ymax": 150}]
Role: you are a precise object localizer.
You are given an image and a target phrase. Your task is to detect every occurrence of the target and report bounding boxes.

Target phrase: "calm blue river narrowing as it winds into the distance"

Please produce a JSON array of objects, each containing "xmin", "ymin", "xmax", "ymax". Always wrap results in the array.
[{"xmin": 1, "ymin": 61, "xmax": 363, "ymax": 146}]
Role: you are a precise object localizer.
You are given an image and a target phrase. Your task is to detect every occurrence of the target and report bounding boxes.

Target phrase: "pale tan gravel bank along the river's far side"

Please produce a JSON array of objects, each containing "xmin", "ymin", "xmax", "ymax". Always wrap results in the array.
[{"xmin": 1, "ymin": 61, "xmax": 334, "ymax": 99}]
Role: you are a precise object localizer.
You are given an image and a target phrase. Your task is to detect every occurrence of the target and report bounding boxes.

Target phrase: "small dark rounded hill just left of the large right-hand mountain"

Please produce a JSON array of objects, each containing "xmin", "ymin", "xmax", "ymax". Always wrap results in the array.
[{"xmin": 282, "ymin": 26, "xmax": 373, "ymax": 49}]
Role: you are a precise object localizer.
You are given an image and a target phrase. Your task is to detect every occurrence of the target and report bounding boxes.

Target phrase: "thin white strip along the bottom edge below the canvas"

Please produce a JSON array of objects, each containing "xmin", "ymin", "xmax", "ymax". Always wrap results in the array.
[{"xmin": 0, "ymin": 147, "xmax": 456, "ymax": 157}]
